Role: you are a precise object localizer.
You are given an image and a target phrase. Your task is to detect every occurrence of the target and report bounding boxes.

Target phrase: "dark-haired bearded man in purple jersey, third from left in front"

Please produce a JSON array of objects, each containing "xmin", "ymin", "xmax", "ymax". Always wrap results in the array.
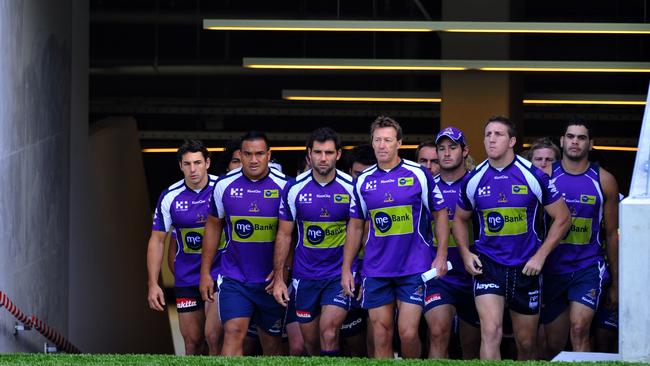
[{"xmin": 273, "ymin": 127, "xmax": 352, "ymax": 356}]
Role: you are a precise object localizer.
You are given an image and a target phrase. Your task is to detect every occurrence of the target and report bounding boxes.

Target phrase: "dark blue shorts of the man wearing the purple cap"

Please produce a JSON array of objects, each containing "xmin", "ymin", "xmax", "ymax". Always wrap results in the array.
[{"xmin": 424, "ymin": 279, "xmax": 480, "ymax": 327}]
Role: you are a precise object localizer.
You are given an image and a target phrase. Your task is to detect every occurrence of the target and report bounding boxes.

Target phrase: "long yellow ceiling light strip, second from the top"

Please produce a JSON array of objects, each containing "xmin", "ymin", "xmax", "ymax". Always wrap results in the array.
[{"xmin": 242, "ymin": 57, "xmax": 650, "ymax": 73}]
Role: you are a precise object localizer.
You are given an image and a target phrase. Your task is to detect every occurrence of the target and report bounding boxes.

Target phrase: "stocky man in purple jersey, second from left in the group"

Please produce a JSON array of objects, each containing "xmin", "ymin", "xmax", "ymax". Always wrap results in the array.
[{"xmin": 200, "ymin": 131, "xmax": 289, "ymax": 356}]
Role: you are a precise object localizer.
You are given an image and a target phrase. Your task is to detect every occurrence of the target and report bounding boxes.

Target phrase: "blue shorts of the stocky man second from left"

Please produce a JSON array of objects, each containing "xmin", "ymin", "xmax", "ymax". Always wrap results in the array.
[{"xmin": 217, "ymin": 276, "xmax": 286, "ymax": 337}]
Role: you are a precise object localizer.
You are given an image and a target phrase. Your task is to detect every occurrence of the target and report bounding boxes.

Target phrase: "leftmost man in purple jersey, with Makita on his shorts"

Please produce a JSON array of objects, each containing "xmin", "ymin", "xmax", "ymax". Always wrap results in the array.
[{"xmin": 147, "ymin": 140, "xmax": 222, "ymax": 355}]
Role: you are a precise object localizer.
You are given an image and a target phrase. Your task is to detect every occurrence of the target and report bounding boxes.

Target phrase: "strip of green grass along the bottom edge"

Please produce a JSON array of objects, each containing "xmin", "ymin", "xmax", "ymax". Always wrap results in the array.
[{"xmin": 0, "ymin": 353, "xmax": 647, "ymax": 366}]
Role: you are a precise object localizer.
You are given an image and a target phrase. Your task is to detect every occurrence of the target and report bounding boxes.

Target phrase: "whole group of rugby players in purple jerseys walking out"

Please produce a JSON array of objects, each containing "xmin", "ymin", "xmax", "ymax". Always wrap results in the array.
[{"xmin": 147, "ymin": 116, "xmax": 619, "ymax": 359}]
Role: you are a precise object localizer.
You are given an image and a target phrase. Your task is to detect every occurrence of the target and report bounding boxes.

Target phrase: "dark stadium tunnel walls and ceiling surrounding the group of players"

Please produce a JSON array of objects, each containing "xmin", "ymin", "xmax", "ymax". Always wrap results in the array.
[{"xmin": 0, "ymin": 0, "xmax": 650, "ymax": 353}]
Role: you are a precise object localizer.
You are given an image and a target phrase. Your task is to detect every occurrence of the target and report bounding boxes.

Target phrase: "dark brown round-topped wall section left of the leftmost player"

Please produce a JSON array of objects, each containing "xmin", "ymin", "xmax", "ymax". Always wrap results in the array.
[{"xmin": 70, "ymin": 118, "xmax": 173, "ymax": 353}]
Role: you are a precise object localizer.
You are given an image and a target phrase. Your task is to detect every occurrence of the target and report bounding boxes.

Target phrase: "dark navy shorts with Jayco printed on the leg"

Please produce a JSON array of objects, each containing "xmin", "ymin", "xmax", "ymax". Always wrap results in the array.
[{"xmin": 474, "ymin": 254, "xmax": 542, "ymax": 315}]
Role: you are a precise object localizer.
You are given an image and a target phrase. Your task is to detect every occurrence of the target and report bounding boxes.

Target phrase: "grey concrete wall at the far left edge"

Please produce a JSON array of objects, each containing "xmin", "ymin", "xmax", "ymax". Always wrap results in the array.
[{"xmin": 0, "ymin": 0, "xmax": 72, "ymax": 352}]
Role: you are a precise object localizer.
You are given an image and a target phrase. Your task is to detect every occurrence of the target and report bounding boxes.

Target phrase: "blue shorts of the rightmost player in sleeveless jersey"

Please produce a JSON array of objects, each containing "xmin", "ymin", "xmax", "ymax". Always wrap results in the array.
[{"xmin": 541, "ymin": 261, "xmax": 605, "ymax": 324}]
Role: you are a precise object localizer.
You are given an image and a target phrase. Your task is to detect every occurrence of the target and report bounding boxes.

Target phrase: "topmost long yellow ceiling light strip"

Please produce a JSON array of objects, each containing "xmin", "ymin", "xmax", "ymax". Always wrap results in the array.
[{"xmin": 203, "ymin": 19, "xmax": 650, "ymax": 35}]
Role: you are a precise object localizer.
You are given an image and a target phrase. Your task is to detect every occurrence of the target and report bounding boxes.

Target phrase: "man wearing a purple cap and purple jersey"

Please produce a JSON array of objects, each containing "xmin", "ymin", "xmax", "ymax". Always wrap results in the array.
[{"xmin": 424, "ymin": 127, "xmax": 481, "ymax": 360}]
